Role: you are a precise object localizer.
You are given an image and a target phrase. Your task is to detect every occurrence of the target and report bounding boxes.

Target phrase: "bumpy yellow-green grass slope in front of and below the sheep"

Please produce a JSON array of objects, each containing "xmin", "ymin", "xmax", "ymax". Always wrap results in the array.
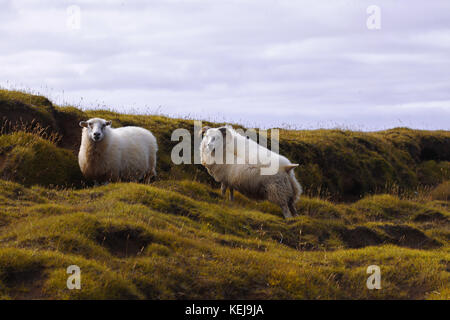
[{"xmin": 0, "ymin": 180, "xmax": 450, "ymax": 299}]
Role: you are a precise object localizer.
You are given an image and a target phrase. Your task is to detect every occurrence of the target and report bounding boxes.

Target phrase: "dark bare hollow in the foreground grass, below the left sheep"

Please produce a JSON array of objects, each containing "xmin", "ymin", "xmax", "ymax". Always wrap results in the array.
[{"xmin": 96, "ymin": 227, "xmax": 152, "ymax": 258}]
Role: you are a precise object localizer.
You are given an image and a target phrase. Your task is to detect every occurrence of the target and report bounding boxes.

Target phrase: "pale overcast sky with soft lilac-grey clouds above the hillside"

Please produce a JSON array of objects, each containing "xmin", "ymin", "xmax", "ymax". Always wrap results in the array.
[{"xmin": 0, "ymin": 0, "xmax": 450, "ymax": 130}]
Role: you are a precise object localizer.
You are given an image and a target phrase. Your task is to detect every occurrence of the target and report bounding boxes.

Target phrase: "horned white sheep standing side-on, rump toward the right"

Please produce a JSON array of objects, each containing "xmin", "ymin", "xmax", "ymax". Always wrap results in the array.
[{"xmin": 200, "ymin": 126, "xmax": 302, "ymax": 218}]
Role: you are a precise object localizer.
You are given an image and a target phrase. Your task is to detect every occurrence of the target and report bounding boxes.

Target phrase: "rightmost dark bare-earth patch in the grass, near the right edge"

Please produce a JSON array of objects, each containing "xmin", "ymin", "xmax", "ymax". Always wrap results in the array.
[{"xmin": 379, "ymin": 225, "xmax": 442, "ymax": 249}]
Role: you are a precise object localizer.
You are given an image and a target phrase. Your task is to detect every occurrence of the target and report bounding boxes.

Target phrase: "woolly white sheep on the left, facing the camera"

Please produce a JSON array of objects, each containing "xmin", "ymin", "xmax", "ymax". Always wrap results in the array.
[{"xmin": 78, "ymin": 118, "xmax": 158, "ymax": 182}]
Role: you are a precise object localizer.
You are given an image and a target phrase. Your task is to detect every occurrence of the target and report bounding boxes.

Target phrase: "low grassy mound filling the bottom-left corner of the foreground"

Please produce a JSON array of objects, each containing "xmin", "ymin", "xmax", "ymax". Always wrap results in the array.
[{"xmin": 0, "ymin": 248, "xmax": 142, "ymax": 299}]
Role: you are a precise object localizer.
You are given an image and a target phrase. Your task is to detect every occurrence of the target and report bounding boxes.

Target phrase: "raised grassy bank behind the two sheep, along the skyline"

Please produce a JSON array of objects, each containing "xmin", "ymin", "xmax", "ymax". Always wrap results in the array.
[{"xmin": 0, "ymin": 90, "xmax": 450, "ymax": 200}]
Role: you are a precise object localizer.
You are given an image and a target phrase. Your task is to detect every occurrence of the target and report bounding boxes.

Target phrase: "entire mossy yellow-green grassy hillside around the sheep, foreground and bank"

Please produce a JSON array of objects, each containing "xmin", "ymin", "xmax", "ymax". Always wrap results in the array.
[{"xmin": 0, "ymin": 90, "xmax": 450, "ymax": 299}]
